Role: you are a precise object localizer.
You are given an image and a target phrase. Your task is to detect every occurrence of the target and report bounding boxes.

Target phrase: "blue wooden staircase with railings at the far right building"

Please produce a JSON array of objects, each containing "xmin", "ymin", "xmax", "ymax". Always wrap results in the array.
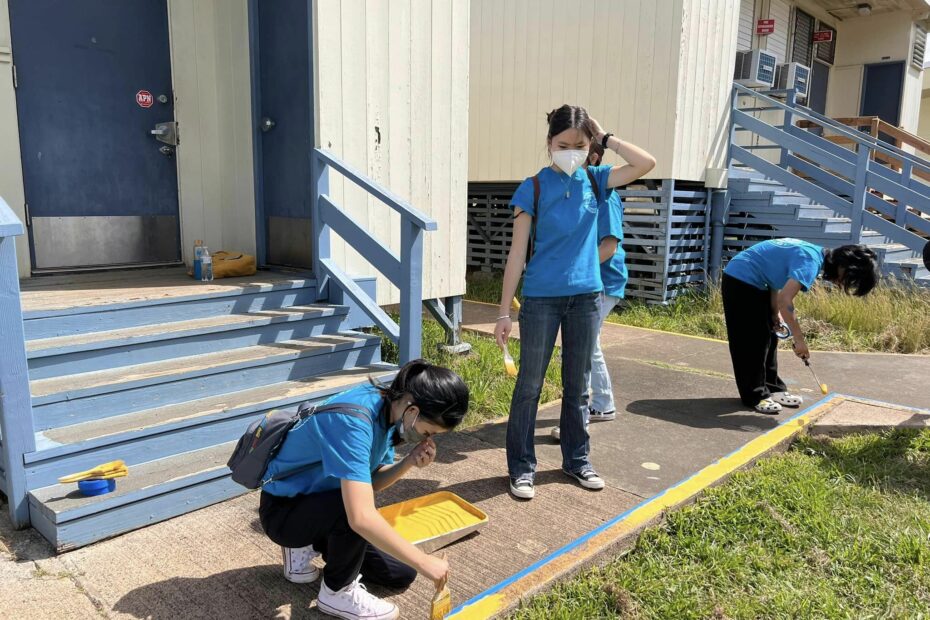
[{"xmin": 723, "ymin": 84, "xmax": 930, "ymax": 286}]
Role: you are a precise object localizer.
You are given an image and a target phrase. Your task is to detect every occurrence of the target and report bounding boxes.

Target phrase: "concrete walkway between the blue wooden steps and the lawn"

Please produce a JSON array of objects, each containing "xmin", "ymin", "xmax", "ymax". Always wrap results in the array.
[{"xmin": 0, "ymin": 304, "xmax": 930, "ymax": 620}]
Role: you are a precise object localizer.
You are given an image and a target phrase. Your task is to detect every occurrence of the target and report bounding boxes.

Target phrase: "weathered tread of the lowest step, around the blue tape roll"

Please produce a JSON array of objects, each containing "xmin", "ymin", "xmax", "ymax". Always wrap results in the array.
[{"xmin": 29, "ymin": 441, "xmax": 236, "ymax": 523}]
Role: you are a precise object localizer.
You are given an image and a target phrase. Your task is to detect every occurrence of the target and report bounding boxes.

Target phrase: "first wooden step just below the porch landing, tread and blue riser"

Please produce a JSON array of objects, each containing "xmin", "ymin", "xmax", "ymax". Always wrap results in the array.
[{"xmin": 26, "ymin": 305, "xmax": 349, "ymax": 379}]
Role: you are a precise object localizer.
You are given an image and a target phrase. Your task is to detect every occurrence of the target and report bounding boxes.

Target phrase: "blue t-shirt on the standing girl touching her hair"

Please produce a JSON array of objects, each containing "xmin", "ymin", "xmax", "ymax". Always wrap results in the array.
[{"xmin": 510, "ymin": 165, "xmax": 611, "ymax": 297}]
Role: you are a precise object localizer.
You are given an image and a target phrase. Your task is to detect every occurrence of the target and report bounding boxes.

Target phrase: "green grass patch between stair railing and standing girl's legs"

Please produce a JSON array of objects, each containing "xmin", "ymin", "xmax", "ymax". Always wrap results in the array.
[{"xmin": 370, "ymin": 317, "xmax": 562, "ymax": 428}]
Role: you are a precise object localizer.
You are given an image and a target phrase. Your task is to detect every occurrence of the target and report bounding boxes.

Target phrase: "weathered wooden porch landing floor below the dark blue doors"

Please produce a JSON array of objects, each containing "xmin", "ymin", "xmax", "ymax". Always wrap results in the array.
[{"xmin": 21, "ymin": 268, "xmax": 312, "ymax": 314}]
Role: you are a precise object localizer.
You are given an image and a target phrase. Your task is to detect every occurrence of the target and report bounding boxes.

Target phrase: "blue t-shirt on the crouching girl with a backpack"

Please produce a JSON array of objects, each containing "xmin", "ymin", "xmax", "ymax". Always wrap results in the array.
[{"xmin": 263, "ymin": 385, "xmax": 394, "ymax": 497}]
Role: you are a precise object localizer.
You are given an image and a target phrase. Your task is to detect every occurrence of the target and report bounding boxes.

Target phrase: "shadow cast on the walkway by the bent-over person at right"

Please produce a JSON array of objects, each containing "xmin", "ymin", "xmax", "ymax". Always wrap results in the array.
[{"xmin": 627, "ymin": 398, "xmax": 794, "ymax": 432}]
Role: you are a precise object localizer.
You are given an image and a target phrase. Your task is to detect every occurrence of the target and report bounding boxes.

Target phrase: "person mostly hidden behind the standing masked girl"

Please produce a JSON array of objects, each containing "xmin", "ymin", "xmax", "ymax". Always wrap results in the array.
[{"xmin": 552, "ymin": 142, "xmax": 627, "ymax": 441}]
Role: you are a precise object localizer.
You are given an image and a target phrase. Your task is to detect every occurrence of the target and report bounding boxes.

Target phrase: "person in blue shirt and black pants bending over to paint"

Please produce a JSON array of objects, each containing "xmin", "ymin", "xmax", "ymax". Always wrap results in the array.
[{"xmin": 721, "ymin": 239, "xmax": 879, "ymax": 413}]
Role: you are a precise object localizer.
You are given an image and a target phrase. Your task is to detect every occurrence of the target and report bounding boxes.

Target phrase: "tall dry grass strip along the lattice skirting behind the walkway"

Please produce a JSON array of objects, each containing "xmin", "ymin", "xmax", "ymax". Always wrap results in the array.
[{"xmin": 466, "ymin": 274, "xmax": 930, "ymax": 354}]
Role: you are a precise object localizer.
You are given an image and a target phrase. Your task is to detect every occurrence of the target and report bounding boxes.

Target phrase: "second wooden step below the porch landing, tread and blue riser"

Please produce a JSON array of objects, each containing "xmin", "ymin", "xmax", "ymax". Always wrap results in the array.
[{"xmin": 30, "ymin": 332, "xmax": 381, "ymax": 431}]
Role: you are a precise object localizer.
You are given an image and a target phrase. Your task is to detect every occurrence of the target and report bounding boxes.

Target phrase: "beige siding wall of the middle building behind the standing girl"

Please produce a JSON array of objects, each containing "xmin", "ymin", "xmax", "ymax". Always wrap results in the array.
[{"xmin": 469, "ymin": 0, "xmax": 739, "ymax": 182}]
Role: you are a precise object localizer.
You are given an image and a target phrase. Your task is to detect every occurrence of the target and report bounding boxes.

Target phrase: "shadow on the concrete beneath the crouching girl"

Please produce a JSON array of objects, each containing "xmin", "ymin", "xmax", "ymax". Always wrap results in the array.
[{"xmin": 113, "ymin": 564, "xmax": 400, "ymax": 620}]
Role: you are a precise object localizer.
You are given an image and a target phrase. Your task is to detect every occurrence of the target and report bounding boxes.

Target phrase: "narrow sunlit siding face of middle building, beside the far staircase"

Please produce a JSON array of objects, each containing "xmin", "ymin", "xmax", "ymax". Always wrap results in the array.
[{"xmin": 672, "ymin": 0, "xmax": 740, "ymax": 187}]
